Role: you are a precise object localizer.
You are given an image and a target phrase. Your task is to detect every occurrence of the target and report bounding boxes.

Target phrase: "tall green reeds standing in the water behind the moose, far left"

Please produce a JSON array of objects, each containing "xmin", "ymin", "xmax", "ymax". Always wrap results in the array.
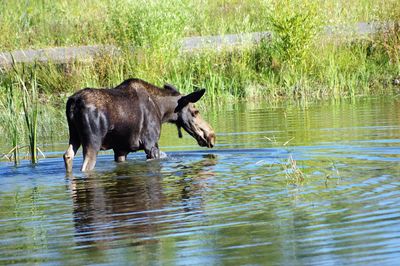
[{"xmin": 0, "ymin": 67, "xmax": 59, "ymax": 165}]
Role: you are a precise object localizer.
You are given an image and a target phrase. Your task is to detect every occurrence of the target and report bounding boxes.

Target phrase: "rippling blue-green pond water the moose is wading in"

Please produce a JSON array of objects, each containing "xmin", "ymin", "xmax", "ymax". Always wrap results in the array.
[{"xmin": 0, "ymin": 98, "xmax": 400, "ymax": 265}]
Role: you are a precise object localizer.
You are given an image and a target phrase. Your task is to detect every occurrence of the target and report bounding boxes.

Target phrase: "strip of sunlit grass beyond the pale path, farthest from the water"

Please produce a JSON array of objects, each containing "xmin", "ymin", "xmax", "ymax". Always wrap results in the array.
[{"xmin": 0, "ymin": 0, "xmax": 399, "ymax": 50}]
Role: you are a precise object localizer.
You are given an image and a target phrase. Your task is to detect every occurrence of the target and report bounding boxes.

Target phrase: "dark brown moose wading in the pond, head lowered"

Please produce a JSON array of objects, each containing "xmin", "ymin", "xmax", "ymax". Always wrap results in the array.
[{"xmin": 64, "ymin": 78, "xmax": 215, "ymax": 172}]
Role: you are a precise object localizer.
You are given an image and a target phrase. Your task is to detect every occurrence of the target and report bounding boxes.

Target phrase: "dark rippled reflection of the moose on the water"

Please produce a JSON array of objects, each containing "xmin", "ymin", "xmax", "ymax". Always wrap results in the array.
[{"xmin": 69, "ymin": 155, "xmax": 216, "ymax": 249}]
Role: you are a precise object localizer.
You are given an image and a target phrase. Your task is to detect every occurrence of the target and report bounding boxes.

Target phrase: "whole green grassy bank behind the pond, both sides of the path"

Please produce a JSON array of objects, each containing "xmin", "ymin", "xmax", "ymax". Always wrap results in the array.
[{"xmin": 0, "ymin": 0, "xmax": 400, "ymax": 162}]
